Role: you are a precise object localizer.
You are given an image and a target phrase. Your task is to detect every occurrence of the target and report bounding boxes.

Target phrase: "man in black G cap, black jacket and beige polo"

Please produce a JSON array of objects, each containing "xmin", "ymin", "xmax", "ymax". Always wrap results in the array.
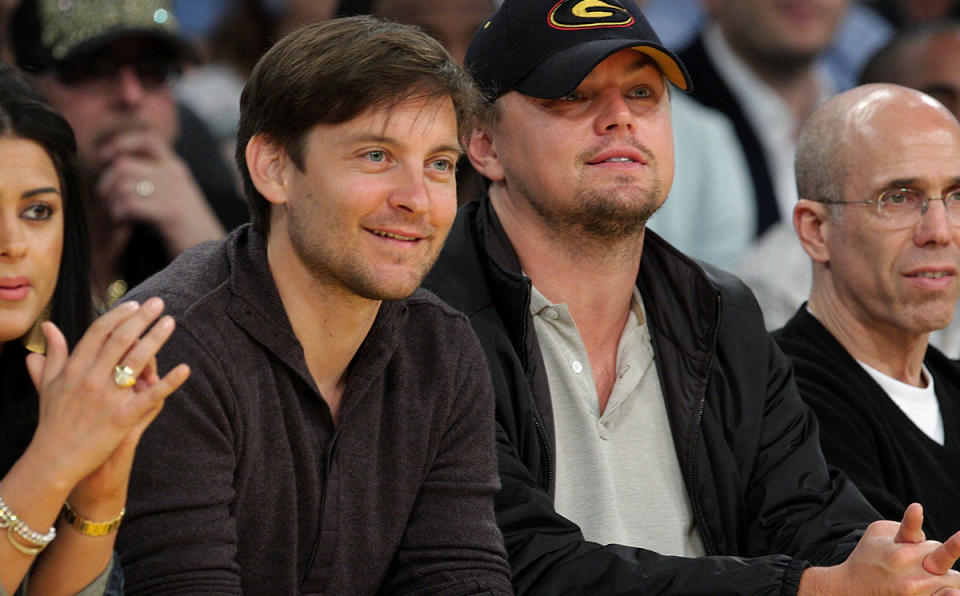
[{"xmin": 425, "ymin": 0, "xmax": 960, "ymax": 594}]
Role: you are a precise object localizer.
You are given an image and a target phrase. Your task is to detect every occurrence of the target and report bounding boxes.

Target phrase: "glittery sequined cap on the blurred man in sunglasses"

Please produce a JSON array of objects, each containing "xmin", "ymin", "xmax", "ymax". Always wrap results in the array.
[{"xmin": 9, "ymin": 0, "xmax": 195, "ymax": 71}]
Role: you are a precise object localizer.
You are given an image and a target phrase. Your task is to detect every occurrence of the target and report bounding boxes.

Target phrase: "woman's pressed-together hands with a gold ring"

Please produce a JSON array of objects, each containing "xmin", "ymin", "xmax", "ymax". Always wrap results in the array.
[{"xmin": 27, "ymin": 298, "xmax": 190, "ymax": 514}]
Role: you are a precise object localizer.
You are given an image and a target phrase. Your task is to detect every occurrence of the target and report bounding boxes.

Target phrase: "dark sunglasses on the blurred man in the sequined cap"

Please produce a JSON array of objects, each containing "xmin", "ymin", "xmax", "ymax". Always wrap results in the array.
[{"xmin": 57, "ymin": 51, "xmax": 180, "ymax": 91}]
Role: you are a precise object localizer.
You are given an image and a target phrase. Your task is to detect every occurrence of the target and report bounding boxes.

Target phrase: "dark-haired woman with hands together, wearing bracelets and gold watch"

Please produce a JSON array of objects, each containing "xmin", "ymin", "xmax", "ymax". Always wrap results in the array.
[{"xmin": 0, "ymin": 64, "xmax": 189, "ymax": 595}]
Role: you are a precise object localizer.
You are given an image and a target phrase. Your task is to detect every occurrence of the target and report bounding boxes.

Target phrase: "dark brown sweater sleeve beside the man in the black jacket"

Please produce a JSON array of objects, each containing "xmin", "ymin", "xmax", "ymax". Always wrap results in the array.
[{"xmin": 383, "ymin": 328, "xmax": 513, "ymax": 596}]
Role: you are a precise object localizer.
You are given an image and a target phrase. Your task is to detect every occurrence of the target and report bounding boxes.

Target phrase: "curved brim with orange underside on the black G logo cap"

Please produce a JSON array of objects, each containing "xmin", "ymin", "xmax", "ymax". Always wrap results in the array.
[{"xmin": 513, "ymin": 39, "xmax": 693, "ymax": 99}]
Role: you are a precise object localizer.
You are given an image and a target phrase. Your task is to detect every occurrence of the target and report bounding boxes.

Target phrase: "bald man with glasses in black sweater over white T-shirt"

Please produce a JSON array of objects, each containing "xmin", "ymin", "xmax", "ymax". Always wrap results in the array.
[{"xmin": 774, "ymin": 84, "xmax": 960, "ymax": 552}]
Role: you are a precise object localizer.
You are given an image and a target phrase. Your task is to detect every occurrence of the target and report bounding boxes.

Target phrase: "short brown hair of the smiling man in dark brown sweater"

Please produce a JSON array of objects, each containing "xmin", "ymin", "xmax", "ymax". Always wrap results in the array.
[{"xmin": 236, "ymin": 16, "xmax": 482, "ymax": 234}]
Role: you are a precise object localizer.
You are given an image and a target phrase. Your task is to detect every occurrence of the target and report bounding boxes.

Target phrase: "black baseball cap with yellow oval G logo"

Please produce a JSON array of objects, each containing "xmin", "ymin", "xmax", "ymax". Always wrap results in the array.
[{"xmin": 464, "ymin": 0, "xmax": 693, "ymax": 101}]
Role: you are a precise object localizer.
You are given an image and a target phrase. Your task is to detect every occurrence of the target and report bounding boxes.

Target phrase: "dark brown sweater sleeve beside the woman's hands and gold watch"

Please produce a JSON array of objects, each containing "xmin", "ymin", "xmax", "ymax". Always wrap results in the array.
[{"xmin": 117, "ymin": 327, "xmax": 241, "ymax": 595}]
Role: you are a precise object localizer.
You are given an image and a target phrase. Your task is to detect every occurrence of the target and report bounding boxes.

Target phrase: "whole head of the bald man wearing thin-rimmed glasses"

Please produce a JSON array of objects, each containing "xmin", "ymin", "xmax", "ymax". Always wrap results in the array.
[{"xmin": 793, "ymin": 83, "xmax": 960, "ymax": 344}]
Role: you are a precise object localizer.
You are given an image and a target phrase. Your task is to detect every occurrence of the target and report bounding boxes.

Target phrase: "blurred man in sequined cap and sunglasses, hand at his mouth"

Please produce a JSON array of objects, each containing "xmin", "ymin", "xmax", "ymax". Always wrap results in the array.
[{"xmin": 8, "ymin": 0, "xmax": 246, "ymax": 303}]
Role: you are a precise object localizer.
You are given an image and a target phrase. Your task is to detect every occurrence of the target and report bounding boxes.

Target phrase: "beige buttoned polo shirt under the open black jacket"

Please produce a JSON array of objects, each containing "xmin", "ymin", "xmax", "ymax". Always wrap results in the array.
[{"xmin": 530, "ymin": 288, "xmax": 705, "ymax": 557}]
